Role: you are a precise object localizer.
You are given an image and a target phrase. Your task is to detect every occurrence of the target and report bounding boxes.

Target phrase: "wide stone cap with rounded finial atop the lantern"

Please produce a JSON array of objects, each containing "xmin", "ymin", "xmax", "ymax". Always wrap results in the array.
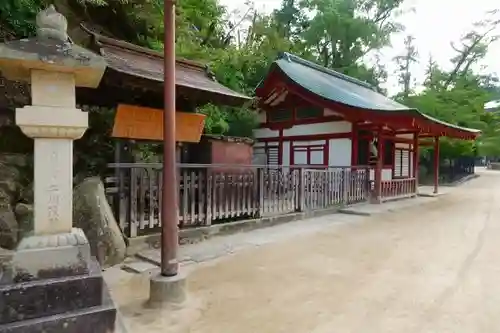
[{"xmin": 0, "ymin": 5, "xmax": 106, "ymax": 88}]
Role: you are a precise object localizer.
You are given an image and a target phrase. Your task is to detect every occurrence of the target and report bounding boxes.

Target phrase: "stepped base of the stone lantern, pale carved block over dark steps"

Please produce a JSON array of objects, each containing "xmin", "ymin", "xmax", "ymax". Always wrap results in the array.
[{"xmin": 0, "ymin": 229, "xmax": 116, "ymax": 333}]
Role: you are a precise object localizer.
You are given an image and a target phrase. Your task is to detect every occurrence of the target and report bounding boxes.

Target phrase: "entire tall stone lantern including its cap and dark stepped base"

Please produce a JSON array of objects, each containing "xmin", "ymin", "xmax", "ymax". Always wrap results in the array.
[{"xmin": 0, "ymin": 6, "xmax": 116, "ymax": 333}]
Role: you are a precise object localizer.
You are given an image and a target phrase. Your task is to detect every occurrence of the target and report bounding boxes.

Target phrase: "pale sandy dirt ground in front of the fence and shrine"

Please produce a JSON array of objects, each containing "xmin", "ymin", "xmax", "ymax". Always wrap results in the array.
[{"xmin": 111, "ymin": 171, "xmax": 500, "ymax": 333}]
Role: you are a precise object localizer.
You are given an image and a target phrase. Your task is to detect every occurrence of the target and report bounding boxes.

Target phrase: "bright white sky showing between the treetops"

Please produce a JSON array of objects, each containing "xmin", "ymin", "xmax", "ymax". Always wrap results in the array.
[{"xmin": 221, "ymin": 0, "xmax": 500, "ymax": 94}]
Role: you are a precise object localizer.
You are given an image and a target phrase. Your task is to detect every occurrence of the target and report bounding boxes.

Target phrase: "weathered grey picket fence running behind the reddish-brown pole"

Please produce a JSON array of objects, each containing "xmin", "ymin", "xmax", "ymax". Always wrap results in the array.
[{"xmin": 105, "ymin": 163, "xmax": 369, "ymax": 237}]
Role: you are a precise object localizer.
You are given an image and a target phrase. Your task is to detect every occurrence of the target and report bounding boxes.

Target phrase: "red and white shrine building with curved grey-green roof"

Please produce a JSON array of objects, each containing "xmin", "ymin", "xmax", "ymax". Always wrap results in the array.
[{"xmin": 254, "ymin": 53, "xmax": 480, "ymax": 202}]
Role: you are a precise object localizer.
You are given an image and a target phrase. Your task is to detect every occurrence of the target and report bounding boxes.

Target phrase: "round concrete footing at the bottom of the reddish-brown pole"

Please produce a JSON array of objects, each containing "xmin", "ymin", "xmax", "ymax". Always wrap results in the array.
[{"xmin": 148, "ymin": 272, "xmax": 187, "ymax": 307}]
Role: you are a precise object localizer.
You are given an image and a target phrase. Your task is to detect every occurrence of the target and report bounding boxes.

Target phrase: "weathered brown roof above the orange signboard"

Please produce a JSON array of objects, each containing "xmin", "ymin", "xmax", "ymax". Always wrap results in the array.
[{"xmin": 81, "ymin": 24, "xmax": 252, "ymax": 106}]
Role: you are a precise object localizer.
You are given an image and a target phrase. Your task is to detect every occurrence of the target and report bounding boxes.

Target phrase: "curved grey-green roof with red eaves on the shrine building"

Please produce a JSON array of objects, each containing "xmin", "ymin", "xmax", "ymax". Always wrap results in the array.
[{"xmin": 256, "ymin": 53, "xmax": 480, "ymax": 139}]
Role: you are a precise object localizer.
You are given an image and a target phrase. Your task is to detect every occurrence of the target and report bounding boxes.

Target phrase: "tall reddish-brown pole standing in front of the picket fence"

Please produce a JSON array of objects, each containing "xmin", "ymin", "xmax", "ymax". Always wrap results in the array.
[{"xmin": 161, "ymin": 0, "xmax": 179, "ymax": 276}]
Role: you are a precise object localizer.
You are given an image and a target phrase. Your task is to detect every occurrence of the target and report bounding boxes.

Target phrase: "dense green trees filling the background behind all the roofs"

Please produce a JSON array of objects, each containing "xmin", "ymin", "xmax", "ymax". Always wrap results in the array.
[{"xmin": 0, "ymin": 0, "xmax": 500, "ymax": 158}]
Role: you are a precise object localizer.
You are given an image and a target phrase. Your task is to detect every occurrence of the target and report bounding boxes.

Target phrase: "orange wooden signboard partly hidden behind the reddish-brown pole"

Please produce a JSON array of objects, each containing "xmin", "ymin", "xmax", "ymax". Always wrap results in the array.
[{"xmin": 112, "ymin": 104, "xmax": 205, "ymax": 142}]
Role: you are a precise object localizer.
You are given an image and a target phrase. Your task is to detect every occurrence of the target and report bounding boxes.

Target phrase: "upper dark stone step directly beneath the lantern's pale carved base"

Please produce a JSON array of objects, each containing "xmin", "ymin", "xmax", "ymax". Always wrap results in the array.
[{"xmin": 0, "ymin": 261, "xmax": 103, "ymax": 322}]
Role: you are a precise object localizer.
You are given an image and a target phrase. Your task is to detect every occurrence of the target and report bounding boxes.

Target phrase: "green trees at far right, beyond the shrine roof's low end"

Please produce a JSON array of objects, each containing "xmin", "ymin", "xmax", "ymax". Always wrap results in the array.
[{"xmin": 398, "ymin": 12, "xmax": 500, "ymax": 158}]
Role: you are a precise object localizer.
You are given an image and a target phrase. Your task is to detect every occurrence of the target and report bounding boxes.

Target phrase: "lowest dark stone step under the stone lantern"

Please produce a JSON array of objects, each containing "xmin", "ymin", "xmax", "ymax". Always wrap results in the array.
[{"xmin": 0, "ymin": 282, "xmax": 117, "ymax": 333}]
